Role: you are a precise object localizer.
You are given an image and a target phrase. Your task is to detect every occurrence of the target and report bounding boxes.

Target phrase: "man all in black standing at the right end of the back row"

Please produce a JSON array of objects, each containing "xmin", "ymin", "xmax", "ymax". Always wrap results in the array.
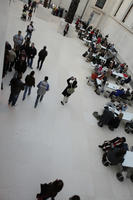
[{"xmin": 37, "ymin": 46, "xmax": 48, "ymax": 70}]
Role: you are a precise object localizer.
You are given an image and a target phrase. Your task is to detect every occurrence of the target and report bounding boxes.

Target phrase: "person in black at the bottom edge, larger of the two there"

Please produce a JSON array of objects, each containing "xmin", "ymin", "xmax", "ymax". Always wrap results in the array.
[{"xmin": 36, "ymin": 179, "xmax": 64, "ymax": 200}]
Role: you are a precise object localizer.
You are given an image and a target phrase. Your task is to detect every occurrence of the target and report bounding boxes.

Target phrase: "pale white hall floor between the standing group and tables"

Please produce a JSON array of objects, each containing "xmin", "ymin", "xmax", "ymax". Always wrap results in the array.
[{"xmin": 0, "ymin": 1, "xmax": 133, "ymax": 200}]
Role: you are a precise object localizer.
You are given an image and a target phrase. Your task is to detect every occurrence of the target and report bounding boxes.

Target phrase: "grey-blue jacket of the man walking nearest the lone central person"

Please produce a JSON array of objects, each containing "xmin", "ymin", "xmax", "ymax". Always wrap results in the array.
[{"xmin": 37, "ymin": 81, "xmax": 49, "ymax": 96}]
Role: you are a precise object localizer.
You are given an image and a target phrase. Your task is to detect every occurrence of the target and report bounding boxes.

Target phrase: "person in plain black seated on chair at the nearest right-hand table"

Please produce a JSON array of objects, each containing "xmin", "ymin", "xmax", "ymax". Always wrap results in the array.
[{"xmin": 102, "ymin": 148, "xmax": 126, "ymax": 167}]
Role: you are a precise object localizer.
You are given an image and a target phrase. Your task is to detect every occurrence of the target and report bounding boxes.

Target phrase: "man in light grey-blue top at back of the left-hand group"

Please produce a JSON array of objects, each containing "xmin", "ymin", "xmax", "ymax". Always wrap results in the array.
[{"xmin": 13, "ymin": 31, "xmax": 24, "ymax": 51}]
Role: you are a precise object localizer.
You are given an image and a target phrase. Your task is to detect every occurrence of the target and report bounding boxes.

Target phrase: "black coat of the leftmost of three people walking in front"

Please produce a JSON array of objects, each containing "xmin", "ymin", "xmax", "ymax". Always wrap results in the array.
[{"xmin": 10, "ymin": 78, "xmax": 24, "ymax": 95}]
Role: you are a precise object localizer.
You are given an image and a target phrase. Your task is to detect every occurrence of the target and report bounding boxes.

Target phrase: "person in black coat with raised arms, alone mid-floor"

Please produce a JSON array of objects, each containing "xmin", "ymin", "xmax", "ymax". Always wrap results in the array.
[{"xmin": 61, "ymin": 76, "xmax": 77, "ymax": 105}]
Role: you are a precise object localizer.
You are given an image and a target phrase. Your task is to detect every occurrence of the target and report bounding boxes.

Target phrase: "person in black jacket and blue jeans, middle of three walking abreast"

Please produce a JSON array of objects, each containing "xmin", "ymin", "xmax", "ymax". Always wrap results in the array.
[{"xmin": 22, "ymin": 71, "xmax": 35, "ymax": 101}]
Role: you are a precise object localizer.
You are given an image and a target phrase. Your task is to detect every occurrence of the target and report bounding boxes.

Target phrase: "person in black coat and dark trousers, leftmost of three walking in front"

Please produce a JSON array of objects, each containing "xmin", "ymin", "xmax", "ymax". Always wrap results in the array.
[{"xmin": 8, "ymin": 74, "xmax": 24, "ymax": 106}]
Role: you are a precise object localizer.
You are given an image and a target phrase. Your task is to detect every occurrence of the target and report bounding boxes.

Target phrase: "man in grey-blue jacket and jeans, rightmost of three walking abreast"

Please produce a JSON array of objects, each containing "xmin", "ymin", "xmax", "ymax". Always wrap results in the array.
[{"xmin": 34, "ymin": 76, "xmax": 49, "ymax": 108}]
